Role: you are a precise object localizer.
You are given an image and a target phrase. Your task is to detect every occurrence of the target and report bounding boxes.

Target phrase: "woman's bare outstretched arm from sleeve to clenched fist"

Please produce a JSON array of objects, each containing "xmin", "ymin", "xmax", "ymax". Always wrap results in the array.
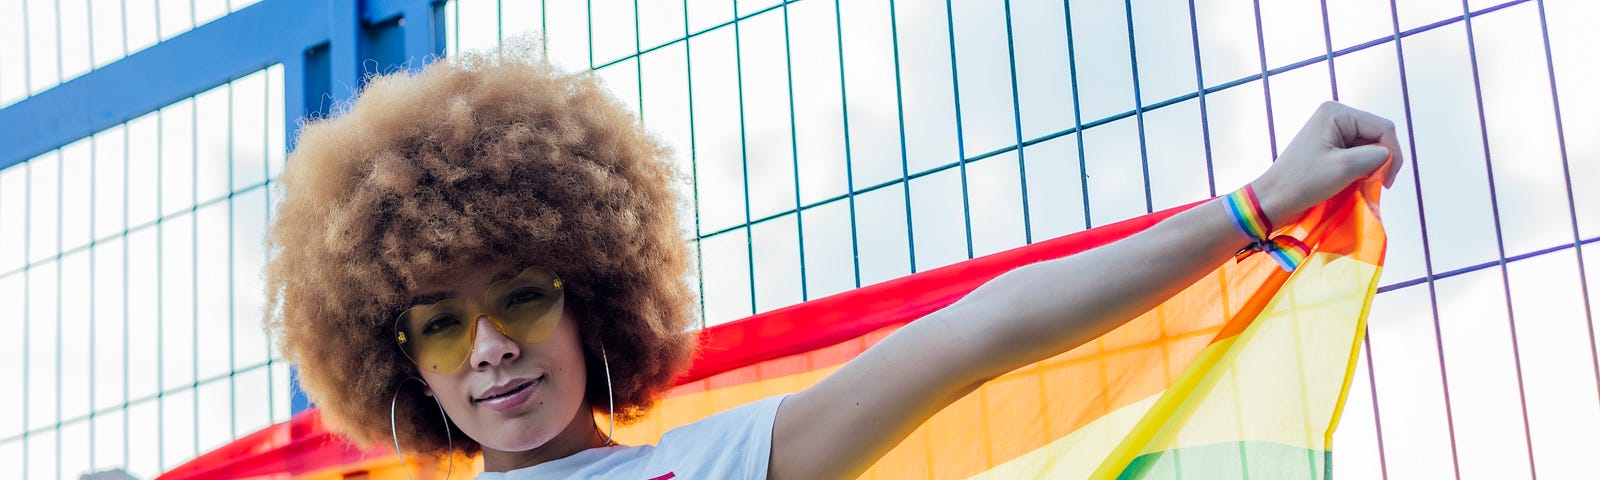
[{"xmin": 770, "ymin": 102, "xmax": 1402, "ymax": 478}]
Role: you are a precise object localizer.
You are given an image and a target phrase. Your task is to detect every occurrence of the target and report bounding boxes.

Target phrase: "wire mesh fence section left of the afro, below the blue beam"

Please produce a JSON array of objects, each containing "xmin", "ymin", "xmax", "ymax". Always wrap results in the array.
[{"xmin": 0, "ymin": 67, "xmax": 290, "ymax": 478}]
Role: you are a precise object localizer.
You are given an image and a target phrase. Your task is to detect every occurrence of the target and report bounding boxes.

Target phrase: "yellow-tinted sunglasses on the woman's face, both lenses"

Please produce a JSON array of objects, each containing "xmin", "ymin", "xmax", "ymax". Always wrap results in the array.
[{"xmin": 395, "ymin": 267, "xmax": 565, "ymax": 373}]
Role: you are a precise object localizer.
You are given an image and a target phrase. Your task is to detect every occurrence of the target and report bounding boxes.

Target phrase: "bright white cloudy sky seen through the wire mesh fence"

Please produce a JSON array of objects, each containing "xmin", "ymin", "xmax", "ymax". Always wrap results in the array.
[{"xmin": 0, "ymin": 0, "xmax": 1600, "ymax": 478}]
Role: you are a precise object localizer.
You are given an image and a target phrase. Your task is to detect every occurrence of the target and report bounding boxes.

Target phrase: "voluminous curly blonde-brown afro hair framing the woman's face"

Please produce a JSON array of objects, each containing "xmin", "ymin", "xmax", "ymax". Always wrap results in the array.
[{"xmin": 266, "ymin": 45, "xmax": 696, "ymax": 456}]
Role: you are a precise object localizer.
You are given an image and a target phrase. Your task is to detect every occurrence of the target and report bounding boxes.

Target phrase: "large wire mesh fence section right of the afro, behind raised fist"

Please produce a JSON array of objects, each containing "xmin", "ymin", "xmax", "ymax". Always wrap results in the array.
[{"xmin": 446, "ymin": 0, "xmax": 1600, "ymax": 478}]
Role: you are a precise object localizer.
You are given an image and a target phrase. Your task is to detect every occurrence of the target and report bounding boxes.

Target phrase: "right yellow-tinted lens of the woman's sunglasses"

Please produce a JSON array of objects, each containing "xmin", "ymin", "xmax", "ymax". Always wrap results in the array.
[{"xmin": 490, "ymin": 267, "xmax": 565, "ymax": 344}]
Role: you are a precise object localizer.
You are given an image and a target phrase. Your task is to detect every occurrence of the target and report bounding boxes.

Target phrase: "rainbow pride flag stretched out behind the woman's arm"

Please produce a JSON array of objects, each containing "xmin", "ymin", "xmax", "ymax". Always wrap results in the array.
[{"xmin": 163, "ymin": 182, "xmax": 1386, "ymax": 478}]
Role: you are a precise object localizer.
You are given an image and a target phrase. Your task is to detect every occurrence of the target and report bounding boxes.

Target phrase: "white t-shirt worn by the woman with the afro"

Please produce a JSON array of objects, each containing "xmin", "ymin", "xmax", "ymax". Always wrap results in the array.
[{"xmin": 478, "ymin": 395, "xmax": 786, "ymax": 480}]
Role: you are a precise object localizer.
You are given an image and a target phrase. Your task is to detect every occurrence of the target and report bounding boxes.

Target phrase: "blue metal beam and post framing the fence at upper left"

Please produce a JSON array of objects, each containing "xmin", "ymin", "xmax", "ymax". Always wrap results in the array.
[{"xmin": 0, "ymin": 0, "xmax": 445, "ymax": 413}]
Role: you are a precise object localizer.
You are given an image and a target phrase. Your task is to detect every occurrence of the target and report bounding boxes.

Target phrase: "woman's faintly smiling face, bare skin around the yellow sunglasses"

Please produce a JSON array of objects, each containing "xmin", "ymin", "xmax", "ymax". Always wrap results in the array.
[{"xmin": 402, "ymin": 262, "xmax": 592, "ymax": 451}]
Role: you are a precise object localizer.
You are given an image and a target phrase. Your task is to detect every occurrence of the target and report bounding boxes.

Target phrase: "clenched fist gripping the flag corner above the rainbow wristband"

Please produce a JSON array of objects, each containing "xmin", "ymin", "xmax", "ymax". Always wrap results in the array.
[{"xmin": 1251, "ymin": 102, "xmax": 1405, "ymax": 226}]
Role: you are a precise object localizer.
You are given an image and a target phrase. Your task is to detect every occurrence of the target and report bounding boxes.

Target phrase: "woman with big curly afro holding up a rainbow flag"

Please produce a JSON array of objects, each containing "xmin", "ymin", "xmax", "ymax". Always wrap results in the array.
[{"xmin": 269, "ymin": 48, "xmax": 1402, "ymax": 478}]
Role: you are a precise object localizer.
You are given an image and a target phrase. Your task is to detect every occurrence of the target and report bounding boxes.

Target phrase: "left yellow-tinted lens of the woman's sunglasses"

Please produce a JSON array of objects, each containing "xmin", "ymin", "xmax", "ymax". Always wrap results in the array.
[{"xmin": 395, "ymin": 299, "xmax": 472, "ymax": 373}]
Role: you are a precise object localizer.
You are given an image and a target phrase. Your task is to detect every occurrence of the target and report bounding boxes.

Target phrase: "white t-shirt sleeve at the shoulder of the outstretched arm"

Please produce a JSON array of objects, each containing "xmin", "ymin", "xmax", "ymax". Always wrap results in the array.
[{"xmin": 645, "ymin": 395, "xmax": 786, "ymax": 478}]
